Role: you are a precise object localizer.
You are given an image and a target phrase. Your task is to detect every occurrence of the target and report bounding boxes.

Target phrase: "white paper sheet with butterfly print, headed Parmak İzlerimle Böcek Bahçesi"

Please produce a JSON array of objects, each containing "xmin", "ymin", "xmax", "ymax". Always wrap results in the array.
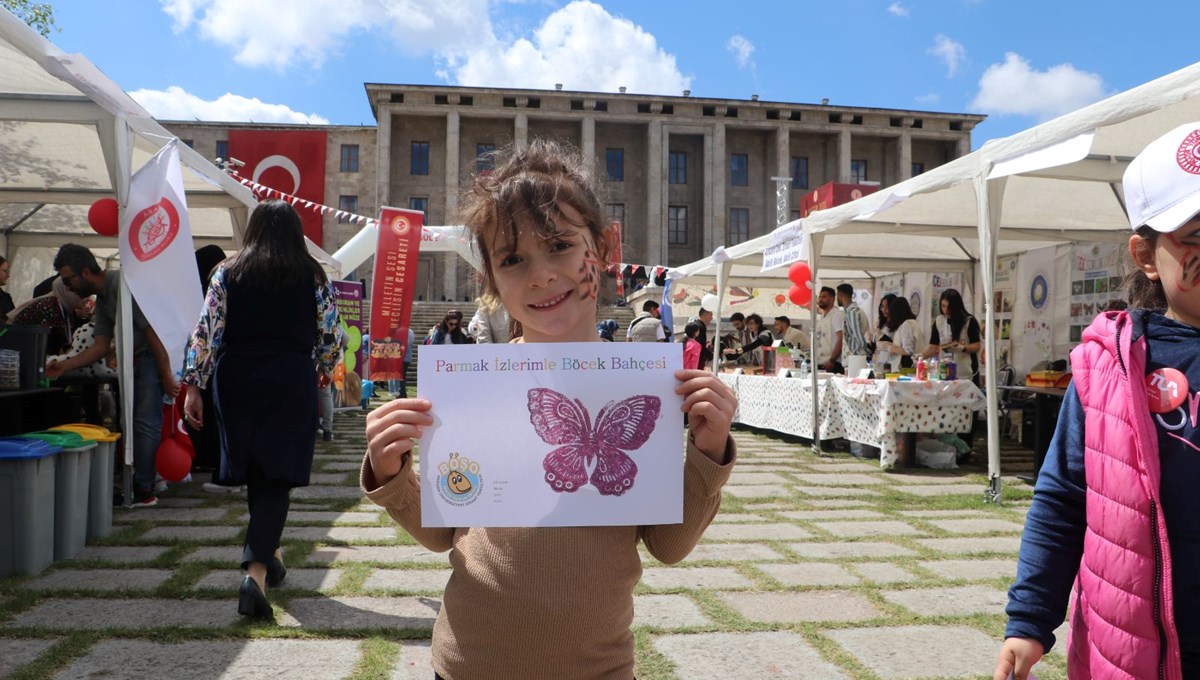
[{"xmin": 418, "ymin": 342, "xmax": 684, "ymax": 526}]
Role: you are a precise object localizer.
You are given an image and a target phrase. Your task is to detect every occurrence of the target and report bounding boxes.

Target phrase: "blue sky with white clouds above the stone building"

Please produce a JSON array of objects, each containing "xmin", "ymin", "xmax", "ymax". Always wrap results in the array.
[{"xmin": 42, "ymin": 0, "xmax": 1200, "ymax": 148}]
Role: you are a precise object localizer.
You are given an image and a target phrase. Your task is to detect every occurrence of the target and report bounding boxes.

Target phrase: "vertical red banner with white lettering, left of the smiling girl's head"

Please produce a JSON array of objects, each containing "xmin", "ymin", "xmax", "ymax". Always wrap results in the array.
[{"xmin": 371, "ymin": 207, "xmax": 425, "ymax": 383}]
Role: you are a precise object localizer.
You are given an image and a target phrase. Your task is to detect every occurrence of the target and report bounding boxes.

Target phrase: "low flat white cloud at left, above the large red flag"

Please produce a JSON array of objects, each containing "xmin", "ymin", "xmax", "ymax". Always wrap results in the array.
[{"xmin": 130, "ymin": 85, "xmax": 329, "ymax": 125}]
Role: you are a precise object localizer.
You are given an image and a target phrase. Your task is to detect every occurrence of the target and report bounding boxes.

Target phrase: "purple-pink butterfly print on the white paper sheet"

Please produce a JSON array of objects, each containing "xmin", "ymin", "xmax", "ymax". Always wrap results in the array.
[{"xmin": 529, "ymin": 387, "xmax": 662, "ymax": 495}]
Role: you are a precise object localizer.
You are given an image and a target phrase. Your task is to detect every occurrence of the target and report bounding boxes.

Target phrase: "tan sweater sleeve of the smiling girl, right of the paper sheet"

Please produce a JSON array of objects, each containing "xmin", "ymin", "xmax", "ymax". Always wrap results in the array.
[{"xmin": 640, "ymin": 432, "xmax": 737, "ymax": 565}]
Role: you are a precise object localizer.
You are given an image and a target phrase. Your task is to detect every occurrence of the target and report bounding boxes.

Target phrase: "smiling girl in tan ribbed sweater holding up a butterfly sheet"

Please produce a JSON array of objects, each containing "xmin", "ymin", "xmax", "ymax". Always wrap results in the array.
[{"xmin": 361, "ymin": 140, "xmax": 737, "ymax": 680}]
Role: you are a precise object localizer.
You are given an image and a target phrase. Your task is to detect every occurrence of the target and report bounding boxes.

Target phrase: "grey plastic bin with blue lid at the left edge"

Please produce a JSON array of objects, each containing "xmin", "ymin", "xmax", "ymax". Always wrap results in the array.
[{"xmin": 0, "ymin": 437, "xmax": 61, "ymax": 578}]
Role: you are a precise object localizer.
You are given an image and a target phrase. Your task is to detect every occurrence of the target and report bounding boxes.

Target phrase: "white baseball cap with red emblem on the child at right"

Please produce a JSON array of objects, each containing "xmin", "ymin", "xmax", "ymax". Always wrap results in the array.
[{"xmin": 1123, "ymin": 122, "xmax": 1200, "ymax": 234}]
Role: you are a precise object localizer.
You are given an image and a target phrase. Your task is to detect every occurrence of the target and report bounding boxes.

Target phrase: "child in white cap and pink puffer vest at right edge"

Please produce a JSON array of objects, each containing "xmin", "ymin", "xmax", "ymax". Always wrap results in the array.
[{"xmin": 995, "ymin": 122, "xmax": 1200, "ymax": 680}]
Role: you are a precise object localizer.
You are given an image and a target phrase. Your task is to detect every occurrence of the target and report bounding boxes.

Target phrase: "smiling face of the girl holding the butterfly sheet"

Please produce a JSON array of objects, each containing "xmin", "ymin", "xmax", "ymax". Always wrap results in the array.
[{"xmin": 491, "ymin": 205, "xmax": 600, "ymax": 342}]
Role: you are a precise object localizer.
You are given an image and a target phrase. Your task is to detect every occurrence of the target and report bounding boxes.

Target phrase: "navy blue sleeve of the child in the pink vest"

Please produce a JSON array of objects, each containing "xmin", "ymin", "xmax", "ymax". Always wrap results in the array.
[{"xmin": 1004, "ymin": 384, "xmax": 1087, "ymax": 652}]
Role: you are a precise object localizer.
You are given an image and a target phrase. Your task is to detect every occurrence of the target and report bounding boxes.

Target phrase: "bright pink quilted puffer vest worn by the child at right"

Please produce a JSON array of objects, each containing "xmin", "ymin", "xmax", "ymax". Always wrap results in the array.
[{"xmin": 1067, "ymin": 312, "xmax": 1182, "ymax": 680}]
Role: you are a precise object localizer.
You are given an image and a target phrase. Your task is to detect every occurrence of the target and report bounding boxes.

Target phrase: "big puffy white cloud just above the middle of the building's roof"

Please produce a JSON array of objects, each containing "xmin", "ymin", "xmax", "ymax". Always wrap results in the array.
[{"xmin": 451, "ymin": 0, "xmax": 691, "ymax": 95}]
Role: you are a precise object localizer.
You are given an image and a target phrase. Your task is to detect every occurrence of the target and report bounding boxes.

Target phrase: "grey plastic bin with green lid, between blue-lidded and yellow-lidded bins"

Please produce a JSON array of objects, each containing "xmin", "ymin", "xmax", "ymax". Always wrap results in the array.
[{"xmin": 22, "ymin": 429, "xmax": 96, "ymax": 560}]
